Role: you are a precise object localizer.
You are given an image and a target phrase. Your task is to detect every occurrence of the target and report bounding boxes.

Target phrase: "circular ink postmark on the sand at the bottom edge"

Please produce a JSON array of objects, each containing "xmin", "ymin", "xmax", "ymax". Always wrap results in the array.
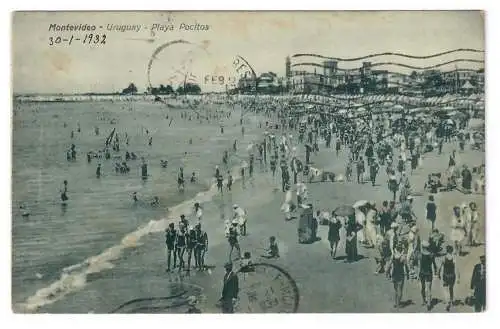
[{"xmin": 236, "ymin": 263, "xmax": 300, "ymax": 313}]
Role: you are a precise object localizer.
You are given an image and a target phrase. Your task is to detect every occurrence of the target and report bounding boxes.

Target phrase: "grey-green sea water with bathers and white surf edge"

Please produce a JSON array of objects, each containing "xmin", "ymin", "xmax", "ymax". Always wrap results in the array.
[{"xmin": 12, "ymin": 102, "xmax": 261, "ymax": 311}]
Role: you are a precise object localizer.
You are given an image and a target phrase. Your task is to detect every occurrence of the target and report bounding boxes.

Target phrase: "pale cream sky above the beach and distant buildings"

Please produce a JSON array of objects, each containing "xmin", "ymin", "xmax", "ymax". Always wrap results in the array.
[{"xmin": 12, "ymin": 11, "xmax": 485, "ymax": 94}]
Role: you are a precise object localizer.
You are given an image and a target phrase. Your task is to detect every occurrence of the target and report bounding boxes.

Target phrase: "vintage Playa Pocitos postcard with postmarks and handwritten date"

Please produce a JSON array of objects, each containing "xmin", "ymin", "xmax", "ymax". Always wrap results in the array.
[{"xmin": 12, "ymin": 11, "xmax": 486, "ymax": 313}]
